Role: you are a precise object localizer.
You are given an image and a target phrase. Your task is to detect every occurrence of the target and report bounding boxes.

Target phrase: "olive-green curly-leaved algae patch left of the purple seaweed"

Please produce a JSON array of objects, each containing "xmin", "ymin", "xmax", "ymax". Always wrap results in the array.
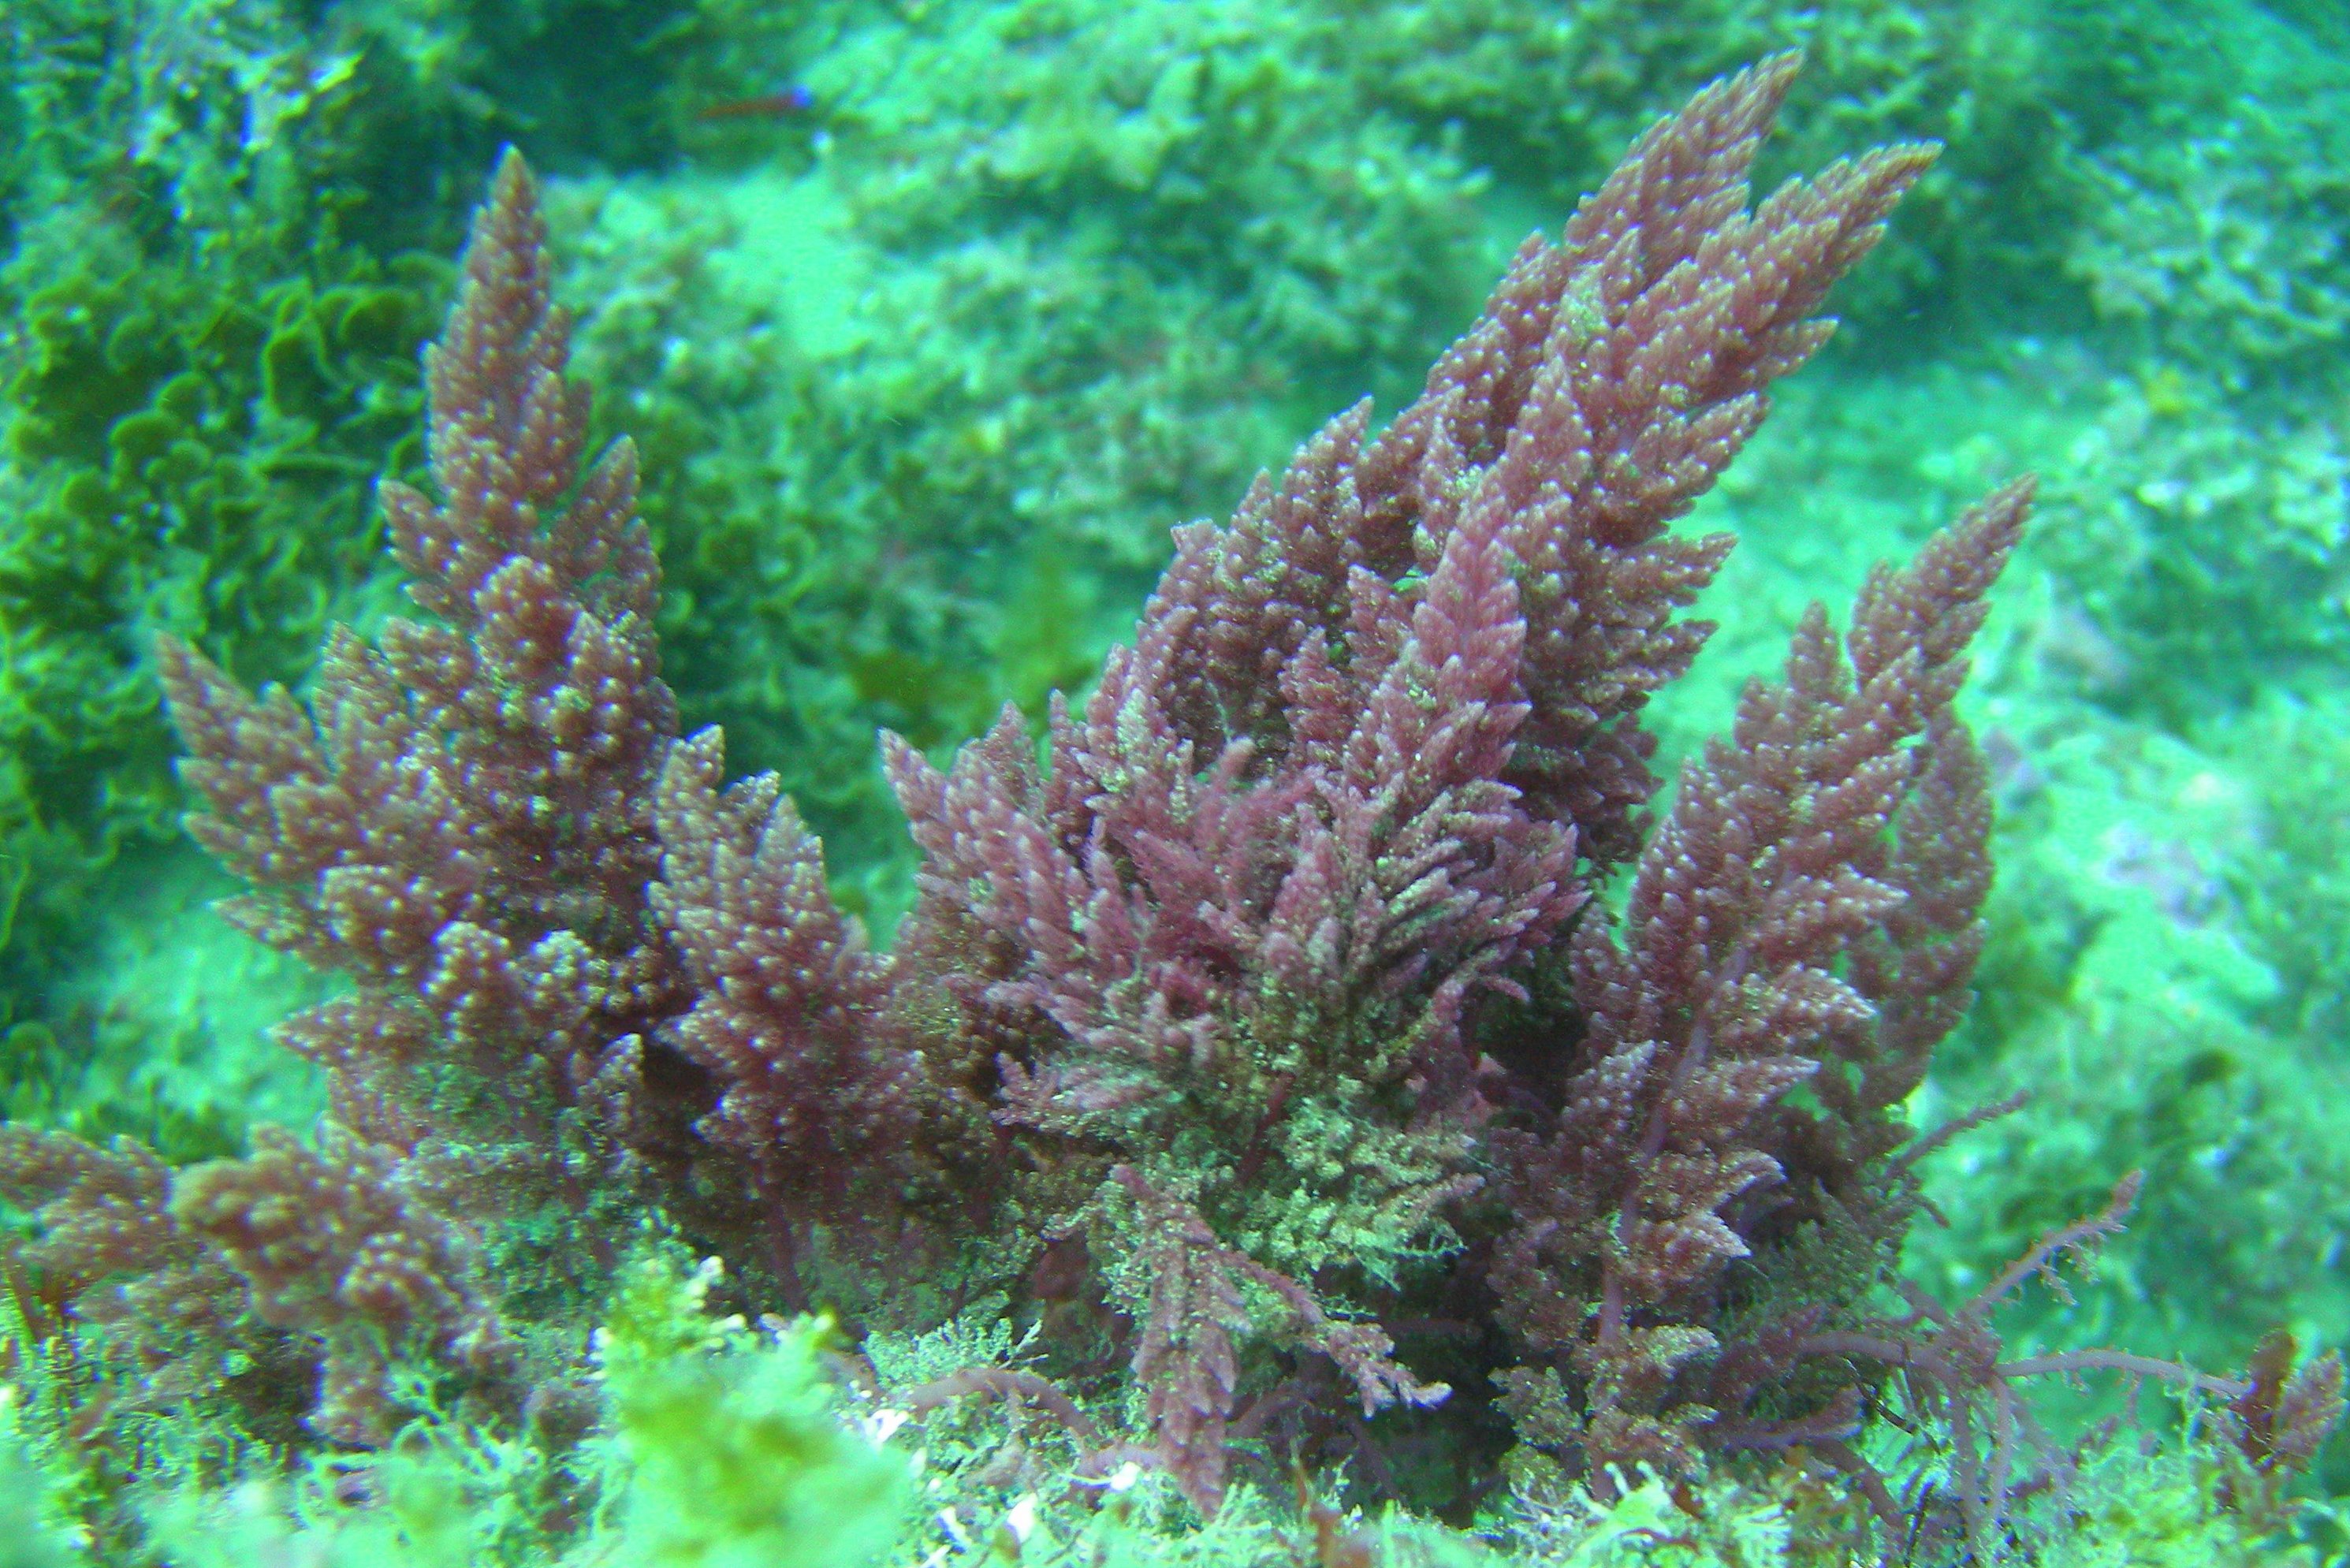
[{"xmin": 0, "ymin": 247, "xmax": 441, "ymax": 1067}]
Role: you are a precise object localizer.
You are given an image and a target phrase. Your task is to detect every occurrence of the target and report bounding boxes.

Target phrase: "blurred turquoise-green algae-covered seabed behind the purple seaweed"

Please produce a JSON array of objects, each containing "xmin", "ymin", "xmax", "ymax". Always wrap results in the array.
[{"xmin": 0, "ymin": 0, "xmax": 2350, "ymax": 1542}]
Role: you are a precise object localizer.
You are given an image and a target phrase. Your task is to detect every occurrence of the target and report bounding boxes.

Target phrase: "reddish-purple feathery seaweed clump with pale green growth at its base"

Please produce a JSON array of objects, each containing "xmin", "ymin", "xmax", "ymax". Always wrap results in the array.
[{"xmin": 0, "ymin": 33, "xmax": 2343, "ymax": 1561}]
